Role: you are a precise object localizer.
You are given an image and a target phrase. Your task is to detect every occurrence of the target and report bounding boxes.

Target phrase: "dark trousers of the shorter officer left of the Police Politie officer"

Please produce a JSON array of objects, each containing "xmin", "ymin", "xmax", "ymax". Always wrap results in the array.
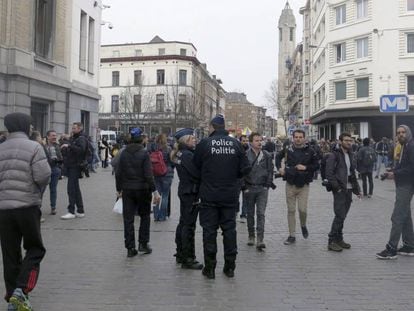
[{"xmin": 175, "ymin": 194, "xmax": 199, "ymax": 261}]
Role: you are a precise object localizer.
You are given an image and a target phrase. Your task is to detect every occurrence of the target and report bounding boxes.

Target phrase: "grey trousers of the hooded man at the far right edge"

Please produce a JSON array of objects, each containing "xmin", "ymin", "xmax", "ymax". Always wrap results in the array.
[{"xmin": 387, "ymin": 185, "xmax": 414, "ymax": 250}]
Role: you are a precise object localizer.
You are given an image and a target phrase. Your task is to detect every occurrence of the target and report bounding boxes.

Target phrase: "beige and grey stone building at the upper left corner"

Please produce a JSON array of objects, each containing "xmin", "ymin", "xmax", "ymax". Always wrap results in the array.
[{"xmin": 0, "ymin": 0, "xmax": 102, "ymax": 135}]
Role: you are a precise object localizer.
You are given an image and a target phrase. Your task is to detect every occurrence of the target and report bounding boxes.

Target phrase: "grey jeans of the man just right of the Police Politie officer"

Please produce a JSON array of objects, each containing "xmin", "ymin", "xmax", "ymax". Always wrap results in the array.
[{"xmin": 245, "ymin": 187, "xmax": 269, "ymax": 241}]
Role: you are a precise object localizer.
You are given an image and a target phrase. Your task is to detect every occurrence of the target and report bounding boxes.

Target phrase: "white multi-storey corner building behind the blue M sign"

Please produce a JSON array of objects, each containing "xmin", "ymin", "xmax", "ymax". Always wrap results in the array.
[{"xmin": 302, "ymin": 0, "xmax": 414, "ymax": 140}]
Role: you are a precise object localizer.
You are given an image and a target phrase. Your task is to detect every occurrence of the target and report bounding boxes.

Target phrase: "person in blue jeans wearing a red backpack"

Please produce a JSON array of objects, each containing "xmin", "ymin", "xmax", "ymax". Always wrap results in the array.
[{"xmin": 149, "ymin": 134, "xmax": 174, "ymax": 221}]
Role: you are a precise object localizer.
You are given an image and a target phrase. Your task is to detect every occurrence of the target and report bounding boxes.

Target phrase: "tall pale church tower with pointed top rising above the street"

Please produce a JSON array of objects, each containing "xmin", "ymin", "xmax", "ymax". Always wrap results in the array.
[{"xmin": 277, "ymin": 0, "xmax": 296, "ymax": 136}]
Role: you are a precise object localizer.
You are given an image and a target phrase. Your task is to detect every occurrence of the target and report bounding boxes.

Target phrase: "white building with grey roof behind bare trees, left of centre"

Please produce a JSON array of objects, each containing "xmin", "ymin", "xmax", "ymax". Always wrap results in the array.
[{"xmin": 99, "ymin": 36, "xmax": 225, "ymax": 137}]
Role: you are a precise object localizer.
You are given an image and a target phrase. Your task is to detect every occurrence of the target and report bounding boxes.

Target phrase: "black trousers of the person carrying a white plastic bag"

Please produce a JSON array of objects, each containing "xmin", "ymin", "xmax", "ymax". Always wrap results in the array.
[{"xmin": 122, "ymin": 190, "xmax": 152, "ymax": 248}]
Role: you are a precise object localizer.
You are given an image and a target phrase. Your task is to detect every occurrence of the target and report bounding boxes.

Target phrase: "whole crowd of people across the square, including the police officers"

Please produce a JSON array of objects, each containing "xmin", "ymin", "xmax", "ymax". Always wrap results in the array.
[{"xmin": 0, "ymin": 113, "xmax": 414, "ymax": 310}]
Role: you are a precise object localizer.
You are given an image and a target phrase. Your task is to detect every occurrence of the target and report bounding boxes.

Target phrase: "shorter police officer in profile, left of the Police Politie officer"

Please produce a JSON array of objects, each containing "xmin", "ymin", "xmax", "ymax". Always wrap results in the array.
[{"xmin": 171, "ymin": 128, "xmax": 203, "ymax": 270}]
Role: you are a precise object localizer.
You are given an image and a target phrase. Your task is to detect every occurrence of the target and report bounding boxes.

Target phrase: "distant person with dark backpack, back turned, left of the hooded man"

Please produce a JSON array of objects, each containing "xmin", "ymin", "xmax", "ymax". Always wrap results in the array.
[{"xmin": 357, "ymin": 138, "xmax": 377, "ymax": 198}]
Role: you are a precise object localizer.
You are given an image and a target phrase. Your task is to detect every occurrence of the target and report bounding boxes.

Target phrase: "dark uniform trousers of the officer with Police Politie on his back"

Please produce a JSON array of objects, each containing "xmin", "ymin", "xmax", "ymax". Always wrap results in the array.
[{"xmin": 200, "ymin": 203, "xmax": 238, "ymax": 269}]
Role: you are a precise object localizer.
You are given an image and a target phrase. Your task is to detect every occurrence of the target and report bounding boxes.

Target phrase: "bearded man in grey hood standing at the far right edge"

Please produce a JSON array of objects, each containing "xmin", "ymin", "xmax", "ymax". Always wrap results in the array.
[{"xmin": 377, "ymin": 125, "xmax": 414, "ymax": 259}]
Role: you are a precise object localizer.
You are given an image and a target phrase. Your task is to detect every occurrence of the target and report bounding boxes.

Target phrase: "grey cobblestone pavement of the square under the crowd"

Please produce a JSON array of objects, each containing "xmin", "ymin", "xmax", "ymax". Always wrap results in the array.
[{"xmin": 1, "ymin": 169, "xmax": 414, "ymax": 311}]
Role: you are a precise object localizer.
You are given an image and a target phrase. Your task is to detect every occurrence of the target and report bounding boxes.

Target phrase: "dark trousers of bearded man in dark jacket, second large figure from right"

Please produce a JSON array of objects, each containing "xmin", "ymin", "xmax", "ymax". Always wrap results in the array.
[{"xmin": 329, "ymin": 190, "xmax": 352, "ymax": 243}]
